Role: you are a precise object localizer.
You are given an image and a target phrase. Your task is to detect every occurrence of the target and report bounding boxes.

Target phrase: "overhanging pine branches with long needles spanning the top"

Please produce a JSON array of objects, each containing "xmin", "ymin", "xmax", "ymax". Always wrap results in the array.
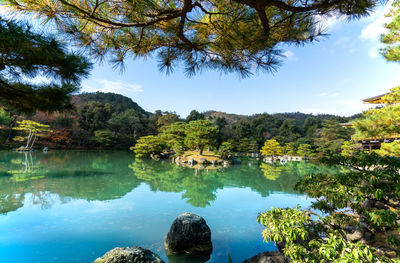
[{"xmin": 2, "ymin": 0, "xmax": 380, "ymax": 76}]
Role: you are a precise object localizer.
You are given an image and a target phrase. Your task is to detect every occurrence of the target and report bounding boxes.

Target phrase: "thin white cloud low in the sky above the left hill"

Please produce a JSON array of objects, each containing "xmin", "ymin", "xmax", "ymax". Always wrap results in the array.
[{"xmin": 82, "ymin": 79, "xmax": 143, "ymax": 95}]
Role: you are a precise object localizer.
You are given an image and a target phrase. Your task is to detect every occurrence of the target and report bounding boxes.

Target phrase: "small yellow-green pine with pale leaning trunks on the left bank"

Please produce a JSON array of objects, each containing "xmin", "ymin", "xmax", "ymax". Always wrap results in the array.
[{"xmin": 13, "ymin": 120, "xmax": 52, "ymax": 150}]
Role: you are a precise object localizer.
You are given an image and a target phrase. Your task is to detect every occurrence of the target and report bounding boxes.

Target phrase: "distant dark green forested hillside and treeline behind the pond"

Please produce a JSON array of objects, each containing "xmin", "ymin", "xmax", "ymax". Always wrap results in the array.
[{"xmin": 0, "ymin": 92, "xmax": 356, "ymax": 152}]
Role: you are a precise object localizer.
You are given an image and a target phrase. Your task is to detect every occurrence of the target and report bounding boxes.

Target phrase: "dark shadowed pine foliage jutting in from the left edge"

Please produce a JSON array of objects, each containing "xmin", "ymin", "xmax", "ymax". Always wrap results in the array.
[{"xmin": 0, "ymin": 17, "xmax": 91, "ymax": 112}]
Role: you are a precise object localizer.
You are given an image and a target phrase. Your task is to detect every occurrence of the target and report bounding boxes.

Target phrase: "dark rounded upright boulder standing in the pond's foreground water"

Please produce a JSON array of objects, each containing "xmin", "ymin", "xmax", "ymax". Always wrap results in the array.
[{"xmin": 164, "ymin": 213, "xmax": 212, "ymax": 255}]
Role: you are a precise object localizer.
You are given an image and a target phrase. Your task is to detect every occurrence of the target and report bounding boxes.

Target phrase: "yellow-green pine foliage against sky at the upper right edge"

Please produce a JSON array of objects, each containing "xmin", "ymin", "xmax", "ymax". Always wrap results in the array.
[{"xmin": 381, "ymin": 0, "xmax": 400, "ymax": 62}]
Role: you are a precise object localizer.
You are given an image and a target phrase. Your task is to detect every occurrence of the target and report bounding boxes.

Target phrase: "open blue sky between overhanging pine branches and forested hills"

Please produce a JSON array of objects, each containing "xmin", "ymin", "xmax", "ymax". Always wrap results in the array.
[{"xmin": 4, "ymin": 2, "xmax": 400, "ymax": 117}]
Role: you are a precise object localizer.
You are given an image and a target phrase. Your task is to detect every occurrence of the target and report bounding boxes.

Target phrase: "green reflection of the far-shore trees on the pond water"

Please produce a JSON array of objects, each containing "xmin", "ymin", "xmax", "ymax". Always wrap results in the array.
[{"xmin": 0, "ymin": 151, "xmax": 340, "ymax": 214}]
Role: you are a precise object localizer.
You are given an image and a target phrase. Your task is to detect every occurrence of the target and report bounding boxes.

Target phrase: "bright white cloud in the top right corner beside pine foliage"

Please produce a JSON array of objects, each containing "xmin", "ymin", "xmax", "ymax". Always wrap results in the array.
[{"xmin": 360, "ymin": 0, "xmax": 393, "ymax": 40}]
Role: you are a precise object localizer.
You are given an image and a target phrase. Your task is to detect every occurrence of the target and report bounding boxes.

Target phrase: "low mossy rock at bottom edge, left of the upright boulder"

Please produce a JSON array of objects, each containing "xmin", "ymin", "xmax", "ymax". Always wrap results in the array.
[{"xmin": 93, "ymin": 247, "xmax": 165, "ymax": 263}]
